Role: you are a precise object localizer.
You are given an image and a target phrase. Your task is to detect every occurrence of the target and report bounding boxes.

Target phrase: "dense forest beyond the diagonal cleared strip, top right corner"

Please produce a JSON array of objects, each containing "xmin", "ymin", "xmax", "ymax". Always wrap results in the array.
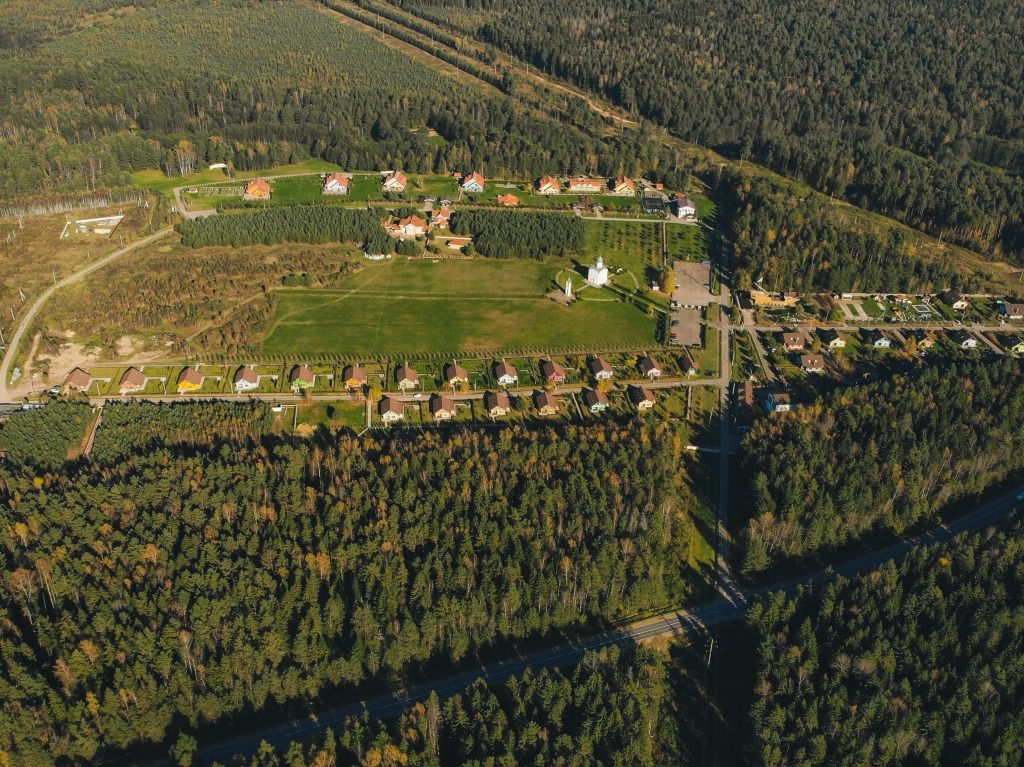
[{"xmin": 391, "ymin": 0, "xmax": 1024, "ymax": 260}]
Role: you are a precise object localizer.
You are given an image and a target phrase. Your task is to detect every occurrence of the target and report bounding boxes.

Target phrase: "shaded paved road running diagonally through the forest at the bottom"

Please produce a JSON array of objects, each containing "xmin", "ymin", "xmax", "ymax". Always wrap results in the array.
[{"xmin": 138, "ymin": 487, "xmax": 1024, "ymax": 767}]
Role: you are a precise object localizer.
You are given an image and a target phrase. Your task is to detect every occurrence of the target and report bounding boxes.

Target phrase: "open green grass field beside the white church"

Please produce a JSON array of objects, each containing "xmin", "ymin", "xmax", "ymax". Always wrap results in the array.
[{"xmin": 263, "ymin": 259, "xmax": 654, "ymax": 356}]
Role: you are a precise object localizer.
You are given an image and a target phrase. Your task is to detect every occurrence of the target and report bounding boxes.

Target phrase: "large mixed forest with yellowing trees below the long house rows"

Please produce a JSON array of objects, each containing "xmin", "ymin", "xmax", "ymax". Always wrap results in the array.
[{"xmin": 0, "ymin": 403, "xmax": 695, "ymax": 767}]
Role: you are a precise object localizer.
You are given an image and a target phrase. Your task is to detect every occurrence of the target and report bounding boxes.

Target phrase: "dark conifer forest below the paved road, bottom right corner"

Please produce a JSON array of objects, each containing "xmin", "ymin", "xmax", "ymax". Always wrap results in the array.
[{"xmin": 746, "ymin": 521, "xmax": 1024, "ymax": 767}]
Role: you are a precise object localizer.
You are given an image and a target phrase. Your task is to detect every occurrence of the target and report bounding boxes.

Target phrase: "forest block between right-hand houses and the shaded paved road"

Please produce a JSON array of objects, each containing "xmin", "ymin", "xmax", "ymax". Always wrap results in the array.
[{"xmin": 741, "ymin": 357, "xmax": 1024, "ymax": 573}]
